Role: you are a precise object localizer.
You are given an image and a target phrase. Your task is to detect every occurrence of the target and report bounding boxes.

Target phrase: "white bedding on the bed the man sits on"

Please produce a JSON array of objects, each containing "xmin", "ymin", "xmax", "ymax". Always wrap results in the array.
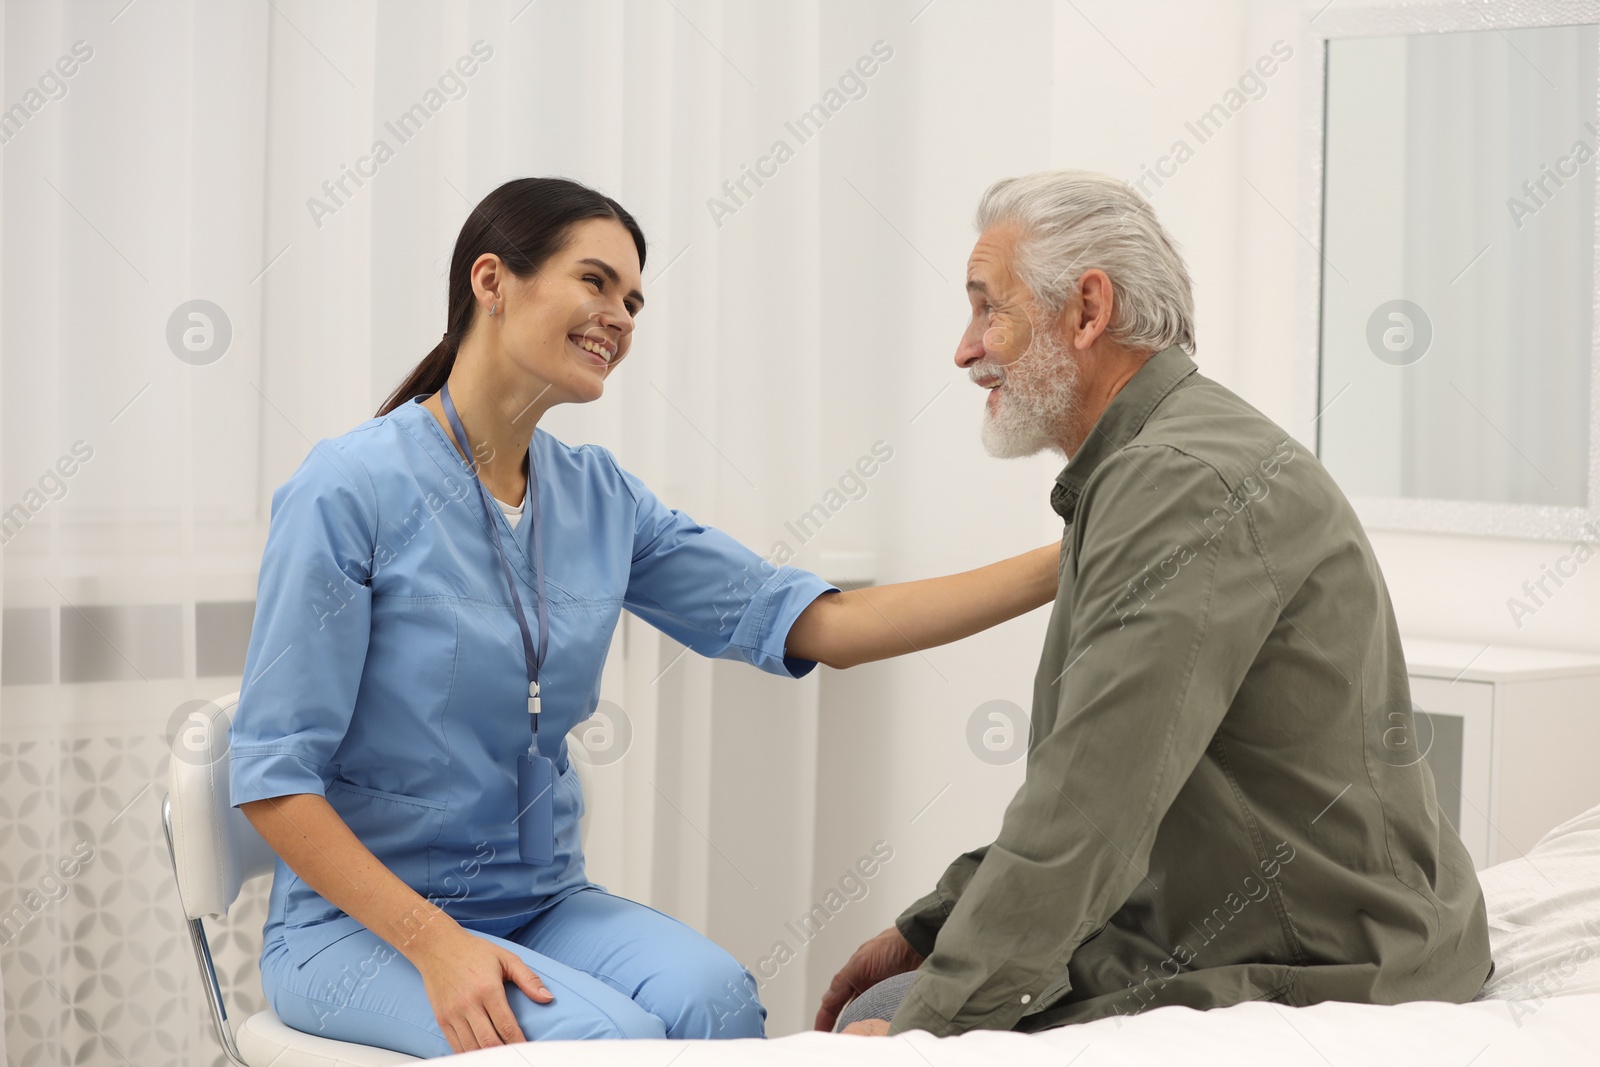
[{"xmin": 422, "ymin": 808, "xmax": 1600, "ymax": 1067}]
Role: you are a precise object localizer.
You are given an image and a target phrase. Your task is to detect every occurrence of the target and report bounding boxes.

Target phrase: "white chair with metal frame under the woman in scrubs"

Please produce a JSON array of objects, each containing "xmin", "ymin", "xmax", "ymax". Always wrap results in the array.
[{"xmin": 162, "ymin": 693, "xmax": 421, "ymax": 1067}]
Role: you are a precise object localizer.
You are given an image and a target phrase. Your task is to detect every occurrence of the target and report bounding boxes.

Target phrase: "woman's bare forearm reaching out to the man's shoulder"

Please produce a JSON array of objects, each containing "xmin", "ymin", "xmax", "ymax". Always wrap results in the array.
[{"xmin": 784, "ymin": 541, "xmax": 1061, "ymax": 667}]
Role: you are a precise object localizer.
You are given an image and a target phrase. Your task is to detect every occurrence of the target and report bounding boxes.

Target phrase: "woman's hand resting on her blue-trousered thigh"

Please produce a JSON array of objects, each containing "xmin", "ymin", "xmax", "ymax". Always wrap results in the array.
[{"xmin": 406, "ymin": 925, "xmax": 555, "ymax": 1053}]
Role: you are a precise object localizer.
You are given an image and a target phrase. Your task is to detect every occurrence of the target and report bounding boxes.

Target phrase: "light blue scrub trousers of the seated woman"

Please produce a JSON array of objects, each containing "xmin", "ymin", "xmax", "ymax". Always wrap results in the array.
[{"xmin": 261, "ymin": 886, "xmax": 766, "ymax": 1059}]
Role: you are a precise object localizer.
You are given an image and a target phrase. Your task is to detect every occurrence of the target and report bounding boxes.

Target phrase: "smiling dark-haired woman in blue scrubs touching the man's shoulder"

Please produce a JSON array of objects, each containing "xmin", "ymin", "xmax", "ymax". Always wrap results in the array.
[{"xmin": 230, "ymin": 178, "xmax": 1058, "ymax": 1057}]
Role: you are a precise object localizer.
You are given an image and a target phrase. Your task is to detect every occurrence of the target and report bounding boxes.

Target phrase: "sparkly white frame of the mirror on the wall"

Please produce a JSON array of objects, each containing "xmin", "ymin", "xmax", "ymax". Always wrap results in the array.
[{"xmin": 1301, "ymin": 0, "xmax": 1600, "ymax": 541}]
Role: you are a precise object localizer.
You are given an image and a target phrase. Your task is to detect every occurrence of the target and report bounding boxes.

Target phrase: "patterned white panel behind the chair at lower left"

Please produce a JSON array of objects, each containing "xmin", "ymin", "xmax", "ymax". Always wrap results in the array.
[{"xmin": 0, "ymin": 734, "xmax": 269, "ymax": 1067}]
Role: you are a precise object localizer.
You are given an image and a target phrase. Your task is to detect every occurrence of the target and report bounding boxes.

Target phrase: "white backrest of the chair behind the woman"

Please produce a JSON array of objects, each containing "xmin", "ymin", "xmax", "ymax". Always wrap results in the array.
[{"xmin": 166, "ymin": 693, "xmax": 277, "ymax": 918}]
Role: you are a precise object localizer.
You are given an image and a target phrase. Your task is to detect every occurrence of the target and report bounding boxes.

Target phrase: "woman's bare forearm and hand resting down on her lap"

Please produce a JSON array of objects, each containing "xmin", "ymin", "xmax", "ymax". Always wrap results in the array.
[{"xmin": 238, "ymin": 793, "xmax": 555, "ymax": 1053}]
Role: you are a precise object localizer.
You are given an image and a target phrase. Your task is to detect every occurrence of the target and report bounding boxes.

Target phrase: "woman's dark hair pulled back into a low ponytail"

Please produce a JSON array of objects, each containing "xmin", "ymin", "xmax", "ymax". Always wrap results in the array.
[{"xmin": 378, "ymin": 178, "xmax": 645, "ymax": 416}]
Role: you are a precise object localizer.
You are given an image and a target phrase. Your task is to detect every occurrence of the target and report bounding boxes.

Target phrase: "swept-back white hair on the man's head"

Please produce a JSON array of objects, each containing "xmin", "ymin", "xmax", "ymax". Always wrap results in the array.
[{"xmin": 978, "ymin": 170, "xmax": 1195, "ymax": 355}]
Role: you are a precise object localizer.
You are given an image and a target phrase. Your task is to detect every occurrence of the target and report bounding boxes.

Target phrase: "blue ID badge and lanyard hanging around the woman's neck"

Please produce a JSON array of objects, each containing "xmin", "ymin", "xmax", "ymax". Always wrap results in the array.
[{"xmin": 438, "ymin": 386, "xmax": 555, "ymax": 867}]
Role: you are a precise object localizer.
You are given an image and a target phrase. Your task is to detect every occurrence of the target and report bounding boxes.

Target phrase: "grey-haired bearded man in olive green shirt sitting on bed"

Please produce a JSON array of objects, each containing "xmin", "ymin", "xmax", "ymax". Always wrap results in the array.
[{"xmin": 816, "ymin": 171, "xmax": 1491, "ymax": 1035}]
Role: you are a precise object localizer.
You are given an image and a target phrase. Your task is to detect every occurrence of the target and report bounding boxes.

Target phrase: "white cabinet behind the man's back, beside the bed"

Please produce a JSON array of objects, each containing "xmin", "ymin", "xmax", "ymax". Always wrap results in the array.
[{"xmin": 1403, "ymin": 638, "xmax": 1600, "ymax": 870}]
